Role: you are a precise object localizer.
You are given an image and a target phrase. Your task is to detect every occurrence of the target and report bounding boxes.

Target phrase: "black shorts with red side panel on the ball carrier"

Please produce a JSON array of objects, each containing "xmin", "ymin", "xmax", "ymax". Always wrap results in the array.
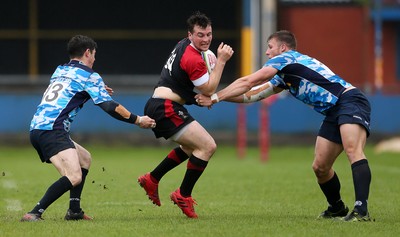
[{"xmin": 144, "ymin": 98, "xmax": 194, "ymax": 139}]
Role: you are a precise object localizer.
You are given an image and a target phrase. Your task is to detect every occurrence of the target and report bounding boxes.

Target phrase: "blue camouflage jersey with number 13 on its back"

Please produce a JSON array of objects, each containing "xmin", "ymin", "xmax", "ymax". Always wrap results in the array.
[{"xmin": 30, "ymin": 60, "xmax": 112, "ymax": 131}]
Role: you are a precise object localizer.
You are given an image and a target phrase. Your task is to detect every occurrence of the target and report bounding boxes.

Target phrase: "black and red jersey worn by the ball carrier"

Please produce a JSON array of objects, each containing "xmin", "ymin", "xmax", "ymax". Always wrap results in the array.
[{"xmin": 157, "ymin": 38, "xmax": 209, "ymax": 105}]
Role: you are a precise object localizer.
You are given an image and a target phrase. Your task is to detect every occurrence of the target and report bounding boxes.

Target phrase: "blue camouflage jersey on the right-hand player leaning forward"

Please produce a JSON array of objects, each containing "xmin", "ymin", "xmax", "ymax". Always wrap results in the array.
[{"xmin": 264, "ymin": 50, "xmax": 352, "ymax": 114}]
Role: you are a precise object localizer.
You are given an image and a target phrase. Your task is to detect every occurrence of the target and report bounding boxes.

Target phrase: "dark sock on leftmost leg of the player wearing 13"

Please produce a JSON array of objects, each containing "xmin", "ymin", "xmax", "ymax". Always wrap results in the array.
[{"xmin": 29, "ymin": 176, "xmax": 72, "ymax": 215}]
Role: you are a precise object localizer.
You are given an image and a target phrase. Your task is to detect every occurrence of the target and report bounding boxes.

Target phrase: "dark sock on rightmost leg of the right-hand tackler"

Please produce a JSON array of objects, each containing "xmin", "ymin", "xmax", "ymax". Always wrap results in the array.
[{"xmin": 351, "ymin": 159, "xmax": 371, "ymax": 215}]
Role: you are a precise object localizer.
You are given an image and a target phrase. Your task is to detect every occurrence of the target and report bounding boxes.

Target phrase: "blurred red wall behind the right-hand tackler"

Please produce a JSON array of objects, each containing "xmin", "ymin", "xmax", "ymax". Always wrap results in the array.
[{"xmin": 278, "ymin": 5, "xmax": 400, "ymax": 91}]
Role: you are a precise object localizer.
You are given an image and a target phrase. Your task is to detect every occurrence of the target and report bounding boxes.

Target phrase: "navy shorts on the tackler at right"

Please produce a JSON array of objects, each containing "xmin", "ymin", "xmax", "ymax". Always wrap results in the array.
[{"xmin": 318, "ymin": 88, "xmax": 371, "ymax": 144}]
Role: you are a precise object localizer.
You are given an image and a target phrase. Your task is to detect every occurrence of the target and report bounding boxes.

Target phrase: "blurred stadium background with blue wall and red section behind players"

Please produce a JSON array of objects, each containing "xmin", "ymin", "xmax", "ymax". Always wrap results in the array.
[{"xmin": 0, "ymin": 0, "xmax": 400, "ymax": 143}]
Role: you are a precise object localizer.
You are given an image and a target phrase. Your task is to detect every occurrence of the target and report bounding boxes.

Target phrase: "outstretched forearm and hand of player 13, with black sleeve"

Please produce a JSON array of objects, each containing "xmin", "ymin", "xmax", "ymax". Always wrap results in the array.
[{"xmin": 98, "ymin": 100, "xmax": 156, "ymax": 128}]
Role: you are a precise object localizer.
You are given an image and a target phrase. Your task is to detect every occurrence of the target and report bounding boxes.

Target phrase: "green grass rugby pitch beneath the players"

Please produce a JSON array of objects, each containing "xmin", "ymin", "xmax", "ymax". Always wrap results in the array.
[{"xmin": 0, "ymin": 143, "xmax": 400, "ymax": 237}]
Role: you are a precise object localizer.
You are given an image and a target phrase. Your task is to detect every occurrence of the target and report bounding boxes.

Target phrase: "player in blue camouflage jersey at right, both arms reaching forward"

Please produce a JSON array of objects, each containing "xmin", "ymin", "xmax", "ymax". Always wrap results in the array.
[{"xmin": 196, "ymin": 30, "xmax": 371, "ymax": 221}]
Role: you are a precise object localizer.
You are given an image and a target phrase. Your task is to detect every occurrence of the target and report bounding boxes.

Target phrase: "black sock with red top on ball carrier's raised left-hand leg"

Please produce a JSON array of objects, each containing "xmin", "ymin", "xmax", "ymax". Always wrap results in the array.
[{"xmin": 150, "ymin": 147, "xmax": 189, "ymax": 181}]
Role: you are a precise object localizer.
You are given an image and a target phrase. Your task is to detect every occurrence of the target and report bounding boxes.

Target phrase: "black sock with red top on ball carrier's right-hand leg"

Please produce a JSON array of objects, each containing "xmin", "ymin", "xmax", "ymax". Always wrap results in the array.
[{"xmin": 180, "ymin": 155, "xmax": 208, "ymax": 197}]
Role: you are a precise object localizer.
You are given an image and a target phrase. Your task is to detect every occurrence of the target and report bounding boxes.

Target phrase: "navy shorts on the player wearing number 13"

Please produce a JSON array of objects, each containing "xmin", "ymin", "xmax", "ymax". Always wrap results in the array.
[{"xmin": 30, "ymin": 129, "xmax": 75, "ymax": 163}]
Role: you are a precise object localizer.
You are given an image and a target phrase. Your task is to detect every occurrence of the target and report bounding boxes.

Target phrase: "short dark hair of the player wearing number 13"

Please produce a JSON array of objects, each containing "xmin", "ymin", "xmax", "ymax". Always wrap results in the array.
[{"xmin": 67, "ymin": 35, "xmax": 97, "ymax": 58}]
